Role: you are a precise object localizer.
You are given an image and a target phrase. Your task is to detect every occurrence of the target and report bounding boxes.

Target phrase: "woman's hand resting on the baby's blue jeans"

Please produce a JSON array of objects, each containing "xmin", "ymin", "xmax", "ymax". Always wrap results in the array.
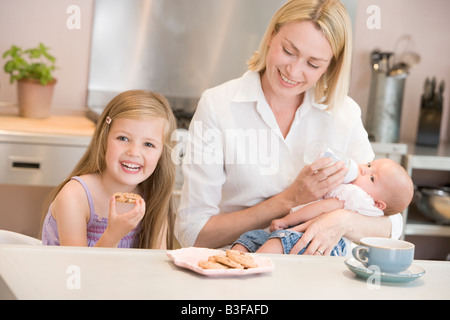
[{"xmin": 289, "ymin": 210, "xmax": 349, "ymax": 256}]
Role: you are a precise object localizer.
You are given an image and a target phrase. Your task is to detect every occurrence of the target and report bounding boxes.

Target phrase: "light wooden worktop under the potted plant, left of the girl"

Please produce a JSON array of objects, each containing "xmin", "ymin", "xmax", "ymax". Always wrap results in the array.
[{"xmin": 0, "ymin": 116, "xmax": 95, "ymax": 136}]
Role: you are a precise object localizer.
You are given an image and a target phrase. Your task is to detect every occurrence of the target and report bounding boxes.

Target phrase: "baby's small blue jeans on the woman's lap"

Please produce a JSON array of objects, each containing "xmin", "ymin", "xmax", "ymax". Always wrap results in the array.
[{"xmin": 233, "ymin": 229, "xmax": 347, "ymax": 256}]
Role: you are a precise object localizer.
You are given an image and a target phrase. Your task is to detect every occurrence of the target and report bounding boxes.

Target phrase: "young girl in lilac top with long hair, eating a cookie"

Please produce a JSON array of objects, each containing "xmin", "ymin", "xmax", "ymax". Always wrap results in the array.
[{"xmin": 42, "ymin": 90, "xmax": 176, "ymax": 249}]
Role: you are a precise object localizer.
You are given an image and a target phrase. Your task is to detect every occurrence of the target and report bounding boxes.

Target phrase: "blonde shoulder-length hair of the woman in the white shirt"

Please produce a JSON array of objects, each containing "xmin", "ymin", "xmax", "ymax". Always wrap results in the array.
[{"xmin": 248, "ymin": 0, "xmax": 352, "ymax": 109}]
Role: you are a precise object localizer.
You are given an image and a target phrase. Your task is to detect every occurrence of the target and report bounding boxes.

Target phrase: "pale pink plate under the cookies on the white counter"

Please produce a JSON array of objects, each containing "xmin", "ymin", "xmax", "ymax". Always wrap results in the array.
[{"xmin": 167, "ymin": 247, "xmax": 274, "ymax": 277}]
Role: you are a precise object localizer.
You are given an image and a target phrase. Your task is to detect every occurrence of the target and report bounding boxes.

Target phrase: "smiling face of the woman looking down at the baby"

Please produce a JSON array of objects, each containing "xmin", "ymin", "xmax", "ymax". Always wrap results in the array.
[{"xmin": 262, "ymin": 21, "xmax": 333, "ymax": 102}]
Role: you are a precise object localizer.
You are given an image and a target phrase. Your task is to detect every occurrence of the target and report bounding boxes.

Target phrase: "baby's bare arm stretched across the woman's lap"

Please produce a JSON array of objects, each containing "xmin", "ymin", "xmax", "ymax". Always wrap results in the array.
[{"xmin": 270, "ymin": 198, "xmax": 344, "ymax": 231}]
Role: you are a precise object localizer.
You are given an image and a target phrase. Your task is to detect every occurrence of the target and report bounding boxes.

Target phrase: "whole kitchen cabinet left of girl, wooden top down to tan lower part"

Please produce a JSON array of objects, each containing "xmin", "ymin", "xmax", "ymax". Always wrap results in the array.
[{"xmin": 0, "ymin": 115, "xmax": 95, "ymax": 238}]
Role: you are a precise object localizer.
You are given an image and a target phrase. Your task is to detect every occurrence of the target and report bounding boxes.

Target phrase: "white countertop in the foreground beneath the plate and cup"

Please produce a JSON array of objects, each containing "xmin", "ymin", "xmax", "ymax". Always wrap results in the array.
[{"xmin": 0, "ymin": 245, "xmax": 450, "ymax": 304}]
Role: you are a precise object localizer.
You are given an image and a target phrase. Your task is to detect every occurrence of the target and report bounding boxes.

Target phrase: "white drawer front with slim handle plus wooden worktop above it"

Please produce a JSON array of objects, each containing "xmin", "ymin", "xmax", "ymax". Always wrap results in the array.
[{"xmin": 0, "ymin": 116, "xmax": 95, "ymax": 187}]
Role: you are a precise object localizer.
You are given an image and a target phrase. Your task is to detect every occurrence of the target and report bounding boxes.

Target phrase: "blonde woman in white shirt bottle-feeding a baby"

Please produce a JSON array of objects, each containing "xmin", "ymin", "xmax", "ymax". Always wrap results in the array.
[{"xmin": 175, "ymin": 0, "xmax": 402, "ymax": 254}]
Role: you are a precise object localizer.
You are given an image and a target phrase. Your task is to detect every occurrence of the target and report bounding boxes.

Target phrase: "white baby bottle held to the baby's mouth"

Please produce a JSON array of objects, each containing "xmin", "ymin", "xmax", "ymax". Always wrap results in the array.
[{"xmin": 303, "ymin": 141, "xmax": 358, "ymax": 183}]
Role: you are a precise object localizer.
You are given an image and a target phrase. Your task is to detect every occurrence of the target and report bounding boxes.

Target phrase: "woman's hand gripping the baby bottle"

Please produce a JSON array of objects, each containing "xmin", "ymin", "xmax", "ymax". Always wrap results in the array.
[{"xmin": 283, "ymin": 158, "xmax": 347, "ymax": 207}]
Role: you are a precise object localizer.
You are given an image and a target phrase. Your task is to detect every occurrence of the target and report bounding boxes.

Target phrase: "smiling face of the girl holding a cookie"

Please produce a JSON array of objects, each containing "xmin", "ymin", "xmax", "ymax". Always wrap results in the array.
[{"xmin": 105, "ymin": 118, "xmax": 165, "ymax": 186}]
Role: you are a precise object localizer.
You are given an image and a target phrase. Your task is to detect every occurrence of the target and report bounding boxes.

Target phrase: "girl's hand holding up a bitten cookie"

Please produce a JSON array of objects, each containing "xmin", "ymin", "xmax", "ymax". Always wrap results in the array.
[{"xmin": 105, "ymin": 196, "xmax": 145, "ymax": 243}]
